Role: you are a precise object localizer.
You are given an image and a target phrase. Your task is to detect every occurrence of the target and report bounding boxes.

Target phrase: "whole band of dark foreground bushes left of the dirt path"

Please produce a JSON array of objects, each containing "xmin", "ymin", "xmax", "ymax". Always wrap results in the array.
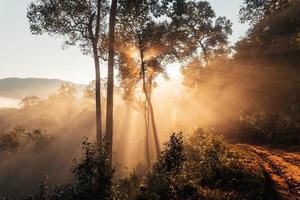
[{"xmin": 5, "ymin": 129, "xmax": 273, "ymax": 200}]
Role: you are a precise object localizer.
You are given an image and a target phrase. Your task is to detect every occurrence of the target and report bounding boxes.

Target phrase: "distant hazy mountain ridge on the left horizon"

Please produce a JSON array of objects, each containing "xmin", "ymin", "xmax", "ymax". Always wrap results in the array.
[{"xmin": 0, "ymin": 78, "xmax": 86, "ymax": 99}]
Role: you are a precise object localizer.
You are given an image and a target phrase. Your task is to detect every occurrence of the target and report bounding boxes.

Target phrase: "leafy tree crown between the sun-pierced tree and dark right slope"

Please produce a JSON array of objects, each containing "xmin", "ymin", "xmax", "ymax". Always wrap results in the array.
[{"xmin": 171, "ymin": 1, "xmax": 232, "ymax": 64}]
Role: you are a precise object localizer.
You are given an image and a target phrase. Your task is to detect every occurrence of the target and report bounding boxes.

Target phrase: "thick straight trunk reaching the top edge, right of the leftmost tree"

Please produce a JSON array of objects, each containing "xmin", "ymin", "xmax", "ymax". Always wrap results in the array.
[{"xmin": 106, "ymin": 0, "xmax": 117, "ymax": 162}]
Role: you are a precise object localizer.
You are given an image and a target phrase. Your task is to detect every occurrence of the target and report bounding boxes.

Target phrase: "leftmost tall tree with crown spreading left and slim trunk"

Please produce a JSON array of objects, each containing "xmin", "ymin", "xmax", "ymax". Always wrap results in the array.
[{"xmin": 27, "ymin": 0, "xmax": 108, "ymax": 145}]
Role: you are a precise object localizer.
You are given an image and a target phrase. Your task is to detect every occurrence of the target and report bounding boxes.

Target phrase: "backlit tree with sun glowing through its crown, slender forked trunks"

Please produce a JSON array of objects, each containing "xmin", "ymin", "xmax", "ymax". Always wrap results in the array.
[{"xmin": 118, "ymin": 0, "xmax": 173, "ymax": 164}]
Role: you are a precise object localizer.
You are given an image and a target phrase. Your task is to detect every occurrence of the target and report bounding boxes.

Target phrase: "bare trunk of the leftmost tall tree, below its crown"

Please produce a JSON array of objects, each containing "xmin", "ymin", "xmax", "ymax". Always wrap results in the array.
[{"xmin": 93, "ymin": 44, "xmax": 102, "ymax": 146}]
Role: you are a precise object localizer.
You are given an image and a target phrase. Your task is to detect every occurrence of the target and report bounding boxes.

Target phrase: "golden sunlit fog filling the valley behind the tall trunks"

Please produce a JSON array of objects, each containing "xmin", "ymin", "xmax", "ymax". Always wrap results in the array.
[{"xmin": 0, "ymin": 80, "xmax": 198, "ymax": 196}]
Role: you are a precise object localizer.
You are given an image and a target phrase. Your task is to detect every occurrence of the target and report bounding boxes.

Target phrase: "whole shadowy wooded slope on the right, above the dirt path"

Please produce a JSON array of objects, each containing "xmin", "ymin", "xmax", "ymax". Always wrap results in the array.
[{"xmin": 182, "ymin": 0, "xmax": 300, "ymax": 149}]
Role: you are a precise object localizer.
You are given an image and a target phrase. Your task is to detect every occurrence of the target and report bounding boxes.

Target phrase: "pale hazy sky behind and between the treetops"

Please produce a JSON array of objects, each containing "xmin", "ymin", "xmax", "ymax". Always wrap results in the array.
[{"xmin": 0, "ymin": 0, "xmax": 248, "ymax": 83}]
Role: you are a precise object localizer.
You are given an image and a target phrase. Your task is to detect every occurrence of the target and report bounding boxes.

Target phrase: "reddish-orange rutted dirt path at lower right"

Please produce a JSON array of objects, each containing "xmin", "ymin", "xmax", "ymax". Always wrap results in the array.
[{"xmin": 246, "ymin": 145, "xmax": 300, "ymax": 200}]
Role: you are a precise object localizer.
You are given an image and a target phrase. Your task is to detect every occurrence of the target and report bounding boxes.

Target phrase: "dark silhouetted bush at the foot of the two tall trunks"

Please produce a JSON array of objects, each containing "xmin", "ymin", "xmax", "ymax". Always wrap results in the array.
[{"xmin": 16, "ymin": 140, "xmax": 114, "ymax": 200}]
